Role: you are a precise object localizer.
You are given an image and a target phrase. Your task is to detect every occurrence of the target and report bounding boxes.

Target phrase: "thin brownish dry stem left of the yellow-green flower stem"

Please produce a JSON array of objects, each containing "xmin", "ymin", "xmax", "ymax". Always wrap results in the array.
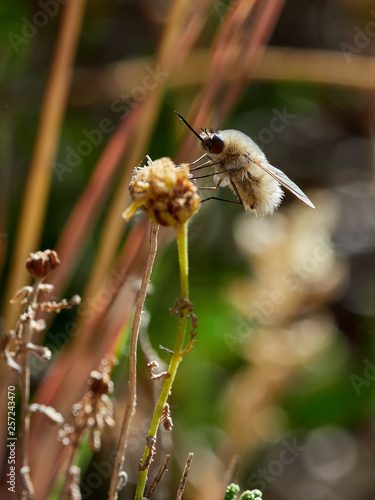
[{"xmin": 108, "ymin": 223, "xmax": 159, "ymax": 500}]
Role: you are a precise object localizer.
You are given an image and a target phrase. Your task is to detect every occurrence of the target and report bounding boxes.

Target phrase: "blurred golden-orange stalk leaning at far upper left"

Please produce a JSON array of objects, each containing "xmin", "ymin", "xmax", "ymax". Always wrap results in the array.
[{"xmin": 4, "ymin": 0, "xmax": 85, "ymax": 325}]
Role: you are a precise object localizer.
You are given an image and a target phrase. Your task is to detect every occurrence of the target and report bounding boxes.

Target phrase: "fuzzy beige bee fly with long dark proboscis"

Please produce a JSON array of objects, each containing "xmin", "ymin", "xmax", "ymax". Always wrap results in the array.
[{"xmin": 175, "ymin": 111, "xmax": 315, "ymax": 217}]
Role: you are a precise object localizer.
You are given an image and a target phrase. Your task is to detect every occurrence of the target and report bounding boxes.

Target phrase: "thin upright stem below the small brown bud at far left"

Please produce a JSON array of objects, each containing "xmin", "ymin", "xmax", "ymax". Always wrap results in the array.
[{"xmin": 19, "ymin": 280, "xmax": 41, "ymax": 500}]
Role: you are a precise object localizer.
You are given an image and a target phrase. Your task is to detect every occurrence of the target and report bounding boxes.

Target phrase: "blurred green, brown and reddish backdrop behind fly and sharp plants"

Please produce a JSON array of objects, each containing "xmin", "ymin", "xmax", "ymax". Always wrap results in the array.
[{"xmin": 0, "ymin": 0, "xmax": 375, "ymax": 500}]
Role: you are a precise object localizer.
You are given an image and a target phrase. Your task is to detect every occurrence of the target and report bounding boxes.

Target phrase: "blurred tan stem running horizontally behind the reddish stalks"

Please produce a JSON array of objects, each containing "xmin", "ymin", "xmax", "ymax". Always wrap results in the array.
[{"xmin": 73, "ymin": 46, "xmax": 375, "ymax": 106}]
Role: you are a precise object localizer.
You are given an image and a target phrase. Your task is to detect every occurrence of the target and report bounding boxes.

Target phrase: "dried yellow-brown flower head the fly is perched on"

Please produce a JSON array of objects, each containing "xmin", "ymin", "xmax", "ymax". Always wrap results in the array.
[{"xmin": 122, "ymin": 158, "xmax": 200, "ymax": 226}]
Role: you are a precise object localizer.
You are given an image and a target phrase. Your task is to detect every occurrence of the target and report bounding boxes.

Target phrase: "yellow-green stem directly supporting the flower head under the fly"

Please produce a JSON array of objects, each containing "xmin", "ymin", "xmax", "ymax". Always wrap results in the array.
[{"xmin": 134, "ymin": 222, "xmax": 189, "ymax": 500}]
